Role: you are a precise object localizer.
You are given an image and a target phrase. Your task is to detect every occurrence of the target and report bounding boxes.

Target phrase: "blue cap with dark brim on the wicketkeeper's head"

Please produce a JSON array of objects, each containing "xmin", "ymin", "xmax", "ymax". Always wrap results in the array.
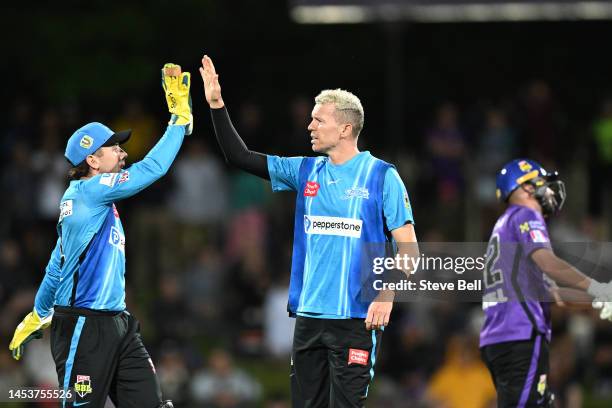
[{"xmin": 64, "ymin": 122, "xmax": 132, "ymax": 166}]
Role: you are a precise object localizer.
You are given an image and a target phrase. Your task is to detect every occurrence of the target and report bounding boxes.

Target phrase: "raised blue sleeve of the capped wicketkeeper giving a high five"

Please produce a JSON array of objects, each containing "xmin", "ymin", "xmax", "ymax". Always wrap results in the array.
[{"xmin": 82, "ymin": 125, "xmax": 185, "ymax": 204}]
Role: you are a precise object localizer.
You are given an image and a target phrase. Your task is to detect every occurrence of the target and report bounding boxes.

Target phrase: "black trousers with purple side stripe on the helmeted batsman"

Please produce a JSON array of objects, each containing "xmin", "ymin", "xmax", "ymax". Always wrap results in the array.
[{"xmin": 481, "ymin": 335, "xmax": 554, "ymax": 408}]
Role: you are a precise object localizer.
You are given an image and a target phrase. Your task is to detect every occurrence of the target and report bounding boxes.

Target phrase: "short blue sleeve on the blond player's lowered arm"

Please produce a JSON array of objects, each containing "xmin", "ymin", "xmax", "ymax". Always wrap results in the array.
[{"xmin": 383, "ymin": 168, "xmax": 414, "ymax": 231}]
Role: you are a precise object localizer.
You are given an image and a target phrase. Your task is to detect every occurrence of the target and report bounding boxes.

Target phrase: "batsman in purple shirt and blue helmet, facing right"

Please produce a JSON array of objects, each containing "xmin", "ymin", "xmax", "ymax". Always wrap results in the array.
[{"xmin": 480, "ymin": 159, "xmax": 612, "ymax": 408}]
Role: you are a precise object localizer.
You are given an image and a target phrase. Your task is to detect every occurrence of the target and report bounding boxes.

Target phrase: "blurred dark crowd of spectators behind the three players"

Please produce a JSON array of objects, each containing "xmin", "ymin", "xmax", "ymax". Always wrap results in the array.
[{"xmin": 0, "ymin": 80, "xmax": 612, "ymax": 408}]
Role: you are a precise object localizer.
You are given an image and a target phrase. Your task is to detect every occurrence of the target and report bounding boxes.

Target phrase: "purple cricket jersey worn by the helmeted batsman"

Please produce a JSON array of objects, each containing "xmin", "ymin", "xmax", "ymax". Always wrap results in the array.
[{"xmin": 480, "ymin": 205, "xmax": 551, "ymax": 347}]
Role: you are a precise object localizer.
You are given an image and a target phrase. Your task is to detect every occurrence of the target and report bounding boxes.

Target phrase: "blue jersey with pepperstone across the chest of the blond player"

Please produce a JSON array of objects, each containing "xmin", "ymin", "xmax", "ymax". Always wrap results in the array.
[{"xmin": 268, "ymin": 151, "xmax": 414, "ymax": 318}]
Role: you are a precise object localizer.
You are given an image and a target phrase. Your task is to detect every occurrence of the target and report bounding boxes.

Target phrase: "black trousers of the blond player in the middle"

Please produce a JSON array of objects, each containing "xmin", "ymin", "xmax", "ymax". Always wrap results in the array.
[{"xmin": 291, "ymin": 316, "xmax": 382, "ymax": 408}]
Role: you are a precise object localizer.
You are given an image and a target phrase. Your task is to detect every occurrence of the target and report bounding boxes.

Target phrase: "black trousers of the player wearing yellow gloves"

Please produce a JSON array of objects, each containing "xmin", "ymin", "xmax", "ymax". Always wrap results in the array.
[{"xmin": 51, "ymin": 307, "xmax": 162, "ymax": 408}]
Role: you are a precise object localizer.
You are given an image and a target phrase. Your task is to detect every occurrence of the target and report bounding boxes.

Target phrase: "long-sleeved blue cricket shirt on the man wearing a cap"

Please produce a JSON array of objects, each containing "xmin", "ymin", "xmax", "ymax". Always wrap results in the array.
[{"xmin": 34, "ymin": 125, "xmax": 185, "ymax": 317}]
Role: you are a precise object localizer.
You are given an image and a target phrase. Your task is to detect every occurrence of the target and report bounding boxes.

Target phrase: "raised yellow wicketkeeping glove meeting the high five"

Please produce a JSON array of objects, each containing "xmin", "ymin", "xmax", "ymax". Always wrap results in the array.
[{"xmin": 162, "ymin": 63, "xmax": 193, "ymax": 135}]
